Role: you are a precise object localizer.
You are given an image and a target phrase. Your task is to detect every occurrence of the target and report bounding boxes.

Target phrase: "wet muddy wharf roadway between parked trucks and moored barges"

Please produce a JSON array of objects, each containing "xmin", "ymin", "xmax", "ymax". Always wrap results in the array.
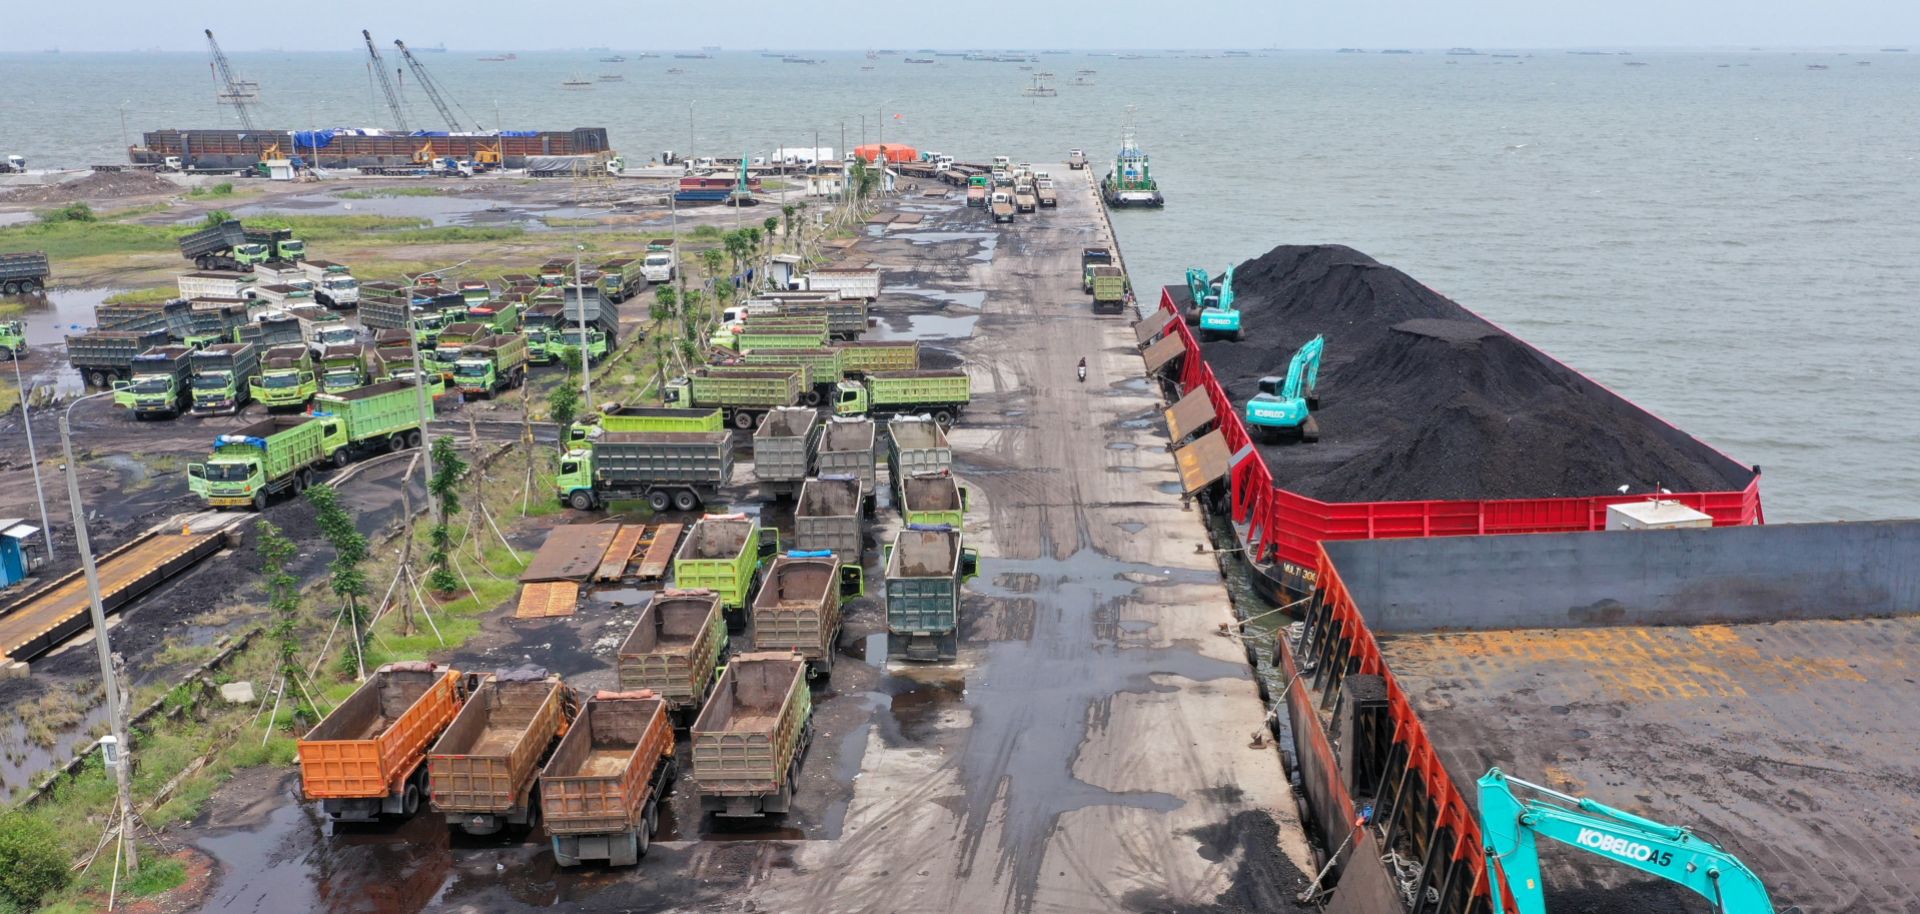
[{"xmin": 165, "ymin": 167, "xmax": 1311, "ymax": 912}]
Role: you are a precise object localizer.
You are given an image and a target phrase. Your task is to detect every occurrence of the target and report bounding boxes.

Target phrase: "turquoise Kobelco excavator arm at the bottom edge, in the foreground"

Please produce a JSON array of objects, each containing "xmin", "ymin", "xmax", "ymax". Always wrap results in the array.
[{"xmin": 1478, "ymin": 768, "xmax": 1799, "ymax": 914}]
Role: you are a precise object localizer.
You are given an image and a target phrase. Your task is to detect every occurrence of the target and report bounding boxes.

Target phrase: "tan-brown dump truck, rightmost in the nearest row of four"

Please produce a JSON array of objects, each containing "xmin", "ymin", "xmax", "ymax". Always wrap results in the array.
[{"xmin": 691, "ymin": 653, "xmax": 814, "ymax": 818}]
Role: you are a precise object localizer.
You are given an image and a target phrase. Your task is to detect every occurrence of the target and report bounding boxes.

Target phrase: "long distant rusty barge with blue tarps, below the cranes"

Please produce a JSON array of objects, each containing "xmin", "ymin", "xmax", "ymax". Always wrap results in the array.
[{"xmin": 127, "ymin": 127, "xmax": 612, "ymax": 171}]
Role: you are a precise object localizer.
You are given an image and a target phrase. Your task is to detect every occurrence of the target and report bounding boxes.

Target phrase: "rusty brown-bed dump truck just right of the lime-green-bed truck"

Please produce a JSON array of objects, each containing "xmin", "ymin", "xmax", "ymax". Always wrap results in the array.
[{"xmin": 753, "ymin": 551, "xmax": 860, "ymax": 676}]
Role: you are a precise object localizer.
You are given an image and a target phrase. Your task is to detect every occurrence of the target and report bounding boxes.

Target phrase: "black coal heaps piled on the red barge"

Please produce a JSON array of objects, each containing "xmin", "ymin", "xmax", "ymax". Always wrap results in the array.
[{"xmin": 1202, "ymin": 246, "xmax": 1753, "ymax": 501}]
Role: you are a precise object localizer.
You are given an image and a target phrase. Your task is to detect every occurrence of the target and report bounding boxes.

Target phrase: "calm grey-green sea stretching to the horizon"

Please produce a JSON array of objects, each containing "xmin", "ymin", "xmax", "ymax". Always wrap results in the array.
[{"xmin": 0, "ymin": 49, "xmax": 1920, "ymax": 520}]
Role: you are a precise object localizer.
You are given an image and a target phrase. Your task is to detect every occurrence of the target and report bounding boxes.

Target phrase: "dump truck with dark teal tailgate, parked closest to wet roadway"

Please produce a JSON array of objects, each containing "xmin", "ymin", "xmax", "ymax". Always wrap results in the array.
[{"xmin": 881, "ymin": 528, "xmax": 979, "ymax": 661}]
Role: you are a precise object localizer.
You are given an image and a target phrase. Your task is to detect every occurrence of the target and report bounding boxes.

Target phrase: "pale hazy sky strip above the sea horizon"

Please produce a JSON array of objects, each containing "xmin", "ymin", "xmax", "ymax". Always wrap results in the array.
[{"xmin": 15, "ymin": 0, "xmax": 1920, "ymax": 52}]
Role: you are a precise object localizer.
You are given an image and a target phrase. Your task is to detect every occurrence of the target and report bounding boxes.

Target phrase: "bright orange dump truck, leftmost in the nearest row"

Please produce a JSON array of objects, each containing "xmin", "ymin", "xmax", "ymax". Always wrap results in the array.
[{"xmin": 300, "ymin": 662, "xmax": 461, "ymax": 822}]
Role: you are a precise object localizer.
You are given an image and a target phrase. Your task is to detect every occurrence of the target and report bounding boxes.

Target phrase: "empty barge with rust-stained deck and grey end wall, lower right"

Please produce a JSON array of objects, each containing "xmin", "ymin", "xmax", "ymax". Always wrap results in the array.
[{"xmin": 1275, "ymin": 520, "xmax": 1920, "ymax": 914}]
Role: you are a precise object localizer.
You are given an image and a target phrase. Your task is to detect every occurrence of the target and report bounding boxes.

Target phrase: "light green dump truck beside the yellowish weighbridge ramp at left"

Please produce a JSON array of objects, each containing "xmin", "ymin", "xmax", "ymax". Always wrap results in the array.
[{"xmin": 186, "ymin": 417, "xmax": 334, "ymax": 511}]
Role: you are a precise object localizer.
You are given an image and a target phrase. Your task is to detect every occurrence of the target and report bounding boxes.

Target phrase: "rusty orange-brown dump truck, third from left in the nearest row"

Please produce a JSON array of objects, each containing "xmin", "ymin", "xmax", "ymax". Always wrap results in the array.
[{"xmin": 540, "ymin": 691, "xmax": 676, "ymax": 866}]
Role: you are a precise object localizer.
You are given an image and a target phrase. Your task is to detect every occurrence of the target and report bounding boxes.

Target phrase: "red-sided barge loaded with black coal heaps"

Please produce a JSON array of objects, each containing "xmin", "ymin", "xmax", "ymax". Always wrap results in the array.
[{"xmin": 1139, "ymin": 246, "xmax": 1763, "ymax": 603}]
